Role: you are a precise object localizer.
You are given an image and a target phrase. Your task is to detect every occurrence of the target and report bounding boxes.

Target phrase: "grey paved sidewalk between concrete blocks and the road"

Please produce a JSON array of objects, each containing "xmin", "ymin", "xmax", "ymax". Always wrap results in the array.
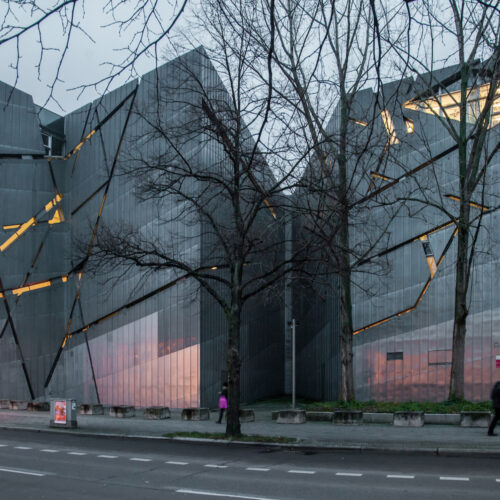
[{"xmin": 0, "ymin": 410, "xmax": 500, "ymax": 458}]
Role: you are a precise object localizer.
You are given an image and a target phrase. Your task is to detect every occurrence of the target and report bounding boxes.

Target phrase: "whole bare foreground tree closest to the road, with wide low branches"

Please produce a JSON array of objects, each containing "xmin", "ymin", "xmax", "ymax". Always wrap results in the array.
[{"xmin": 88, "ymin": 0, "xmax": 312, "ymax": 436}]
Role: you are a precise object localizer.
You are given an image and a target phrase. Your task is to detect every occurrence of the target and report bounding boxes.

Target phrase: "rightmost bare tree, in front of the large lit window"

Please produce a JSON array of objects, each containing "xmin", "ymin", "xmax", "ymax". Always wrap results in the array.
[{"xmin": 394, "ymin": 0, "xmax": 500, "ymax": 399}]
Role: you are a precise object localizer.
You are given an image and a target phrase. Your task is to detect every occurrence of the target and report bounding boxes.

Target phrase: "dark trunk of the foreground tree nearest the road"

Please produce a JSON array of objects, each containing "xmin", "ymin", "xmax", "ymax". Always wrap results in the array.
[{"xmin": 226, "ymin": 280, "xmax": 242, "ymax": 437}]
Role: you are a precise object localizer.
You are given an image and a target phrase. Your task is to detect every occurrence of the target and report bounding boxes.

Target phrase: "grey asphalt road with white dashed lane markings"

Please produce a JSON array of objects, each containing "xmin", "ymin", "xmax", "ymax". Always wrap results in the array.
[{"xmin": 0, "ymin": 430, "xmax": 500, "ymax": 500}]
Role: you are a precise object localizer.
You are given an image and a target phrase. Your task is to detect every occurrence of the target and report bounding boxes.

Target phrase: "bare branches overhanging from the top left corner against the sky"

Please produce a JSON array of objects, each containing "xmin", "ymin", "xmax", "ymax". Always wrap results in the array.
[{"xmin": 0, "ymin": 0, "xmax": 188, "ymax": 108}]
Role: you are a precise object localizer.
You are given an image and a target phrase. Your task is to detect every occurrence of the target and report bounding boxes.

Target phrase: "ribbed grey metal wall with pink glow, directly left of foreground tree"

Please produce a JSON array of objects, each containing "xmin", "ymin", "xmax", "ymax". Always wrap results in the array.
[{"xmin": 50, "ymin": 49, "xmax": 206, "ymax": 408}]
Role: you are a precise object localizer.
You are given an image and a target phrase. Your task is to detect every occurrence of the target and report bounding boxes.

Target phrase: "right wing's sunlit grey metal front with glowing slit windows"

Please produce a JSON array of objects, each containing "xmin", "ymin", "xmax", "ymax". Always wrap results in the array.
[{"xmin": 348, "ymin": 63, "xmax": 500, "ymax": 401}]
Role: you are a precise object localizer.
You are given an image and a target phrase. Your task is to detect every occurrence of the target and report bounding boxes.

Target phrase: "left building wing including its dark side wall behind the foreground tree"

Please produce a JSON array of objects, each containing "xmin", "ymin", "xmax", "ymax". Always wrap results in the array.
[{"xmin": 0, "ymin": 49, "xmax": 283, "ymax": 408}]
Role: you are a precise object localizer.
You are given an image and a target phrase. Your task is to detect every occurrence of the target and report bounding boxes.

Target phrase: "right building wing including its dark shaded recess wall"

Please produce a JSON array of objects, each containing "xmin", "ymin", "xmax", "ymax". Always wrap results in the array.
[{"xmin": 295, "ymin": 64, "xmax": 500, "ymax": 401}]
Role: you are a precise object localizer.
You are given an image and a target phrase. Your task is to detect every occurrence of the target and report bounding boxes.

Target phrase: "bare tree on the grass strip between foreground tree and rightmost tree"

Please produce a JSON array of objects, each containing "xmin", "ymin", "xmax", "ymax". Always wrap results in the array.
[{"xmin": 252, "ymin": 0, "xmax": 408, "ymax": 400}]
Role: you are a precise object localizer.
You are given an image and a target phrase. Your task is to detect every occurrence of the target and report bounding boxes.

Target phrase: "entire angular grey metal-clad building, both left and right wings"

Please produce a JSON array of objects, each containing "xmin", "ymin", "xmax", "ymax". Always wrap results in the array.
[{"xmin": 0, "ymin": 49, "xmax": 500, "ymax": 408}]
